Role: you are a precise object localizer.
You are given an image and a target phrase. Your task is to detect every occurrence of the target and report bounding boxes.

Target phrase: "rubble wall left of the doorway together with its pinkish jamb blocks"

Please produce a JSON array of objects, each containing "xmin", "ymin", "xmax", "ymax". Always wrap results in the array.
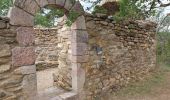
[{"xmin": 0, "ymin": 17, "xmax": 37, "ymax": 100}]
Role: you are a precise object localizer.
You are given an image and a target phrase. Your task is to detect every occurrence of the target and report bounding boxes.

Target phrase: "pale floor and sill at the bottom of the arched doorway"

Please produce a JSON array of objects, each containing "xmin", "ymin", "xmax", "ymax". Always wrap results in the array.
[{"xmin": 36, "ymin": 68, "xmax": 66, "ymax": 100}]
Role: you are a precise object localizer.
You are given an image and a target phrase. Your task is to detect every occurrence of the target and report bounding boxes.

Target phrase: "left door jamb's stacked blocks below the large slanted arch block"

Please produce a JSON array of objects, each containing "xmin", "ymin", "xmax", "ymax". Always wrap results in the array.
[{"xmin": 12, "ymin": 27, "xmax": 37, "ymax": 100}]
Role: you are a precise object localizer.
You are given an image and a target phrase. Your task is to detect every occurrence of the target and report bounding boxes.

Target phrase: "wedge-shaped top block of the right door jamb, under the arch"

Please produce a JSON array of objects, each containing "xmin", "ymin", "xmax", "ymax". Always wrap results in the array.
[{"xmin": 71, "ymin": 15, "xmax": 86, "ymax": 30}]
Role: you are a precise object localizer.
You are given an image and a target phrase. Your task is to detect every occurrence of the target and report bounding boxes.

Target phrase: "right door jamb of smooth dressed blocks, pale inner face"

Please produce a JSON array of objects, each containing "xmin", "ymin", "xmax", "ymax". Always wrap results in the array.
[{"xmin": 71, "ymin": 16, "xmax": 88, "ymax": 99}]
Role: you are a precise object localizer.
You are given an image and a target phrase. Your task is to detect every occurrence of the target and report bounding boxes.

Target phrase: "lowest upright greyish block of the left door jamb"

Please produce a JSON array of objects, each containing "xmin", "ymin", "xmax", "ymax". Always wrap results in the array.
[{"xmin": 22, "ymin": 74, "xmax": 37, "ymax": 100}]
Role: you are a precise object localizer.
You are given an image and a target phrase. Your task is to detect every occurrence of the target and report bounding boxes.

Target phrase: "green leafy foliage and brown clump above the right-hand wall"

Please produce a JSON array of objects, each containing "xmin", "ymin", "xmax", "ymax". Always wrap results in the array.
[{"xmin": 93, "ymin": 0, "xmax": 156, "ymax": 21}]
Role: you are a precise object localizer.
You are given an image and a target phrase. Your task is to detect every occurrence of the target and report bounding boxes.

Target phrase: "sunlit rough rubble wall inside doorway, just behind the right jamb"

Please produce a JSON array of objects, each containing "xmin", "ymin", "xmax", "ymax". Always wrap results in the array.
[{"xmin": 53, "ymin": 17, "xmax": 72, "ymax": 90}]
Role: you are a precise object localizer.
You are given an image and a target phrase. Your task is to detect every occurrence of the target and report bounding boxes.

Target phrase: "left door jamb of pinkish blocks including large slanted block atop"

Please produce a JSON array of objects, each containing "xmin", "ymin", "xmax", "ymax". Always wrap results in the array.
[{"xmin": 8, "ymin": 4, "xmax": 37, "ymax": 100}]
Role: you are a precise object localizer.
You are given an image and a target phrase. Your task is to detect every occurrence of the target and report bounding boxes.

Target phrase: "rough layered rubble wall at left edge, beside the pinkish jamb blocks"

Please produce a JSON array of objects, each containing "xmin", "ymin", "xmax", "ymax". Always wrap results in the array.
[{"xmin": 0, "ymin": 17, "xmax": 23, "ymax": 100}]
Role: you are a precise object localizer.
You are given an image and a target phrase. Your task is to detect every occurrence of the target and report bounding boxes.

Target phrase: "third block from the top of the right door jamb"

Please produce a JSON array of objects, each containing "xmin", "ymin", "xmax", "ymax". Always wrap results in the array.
[{"xmin": 71, "ymin": 43, "xmax": 87, "ymax": 56}]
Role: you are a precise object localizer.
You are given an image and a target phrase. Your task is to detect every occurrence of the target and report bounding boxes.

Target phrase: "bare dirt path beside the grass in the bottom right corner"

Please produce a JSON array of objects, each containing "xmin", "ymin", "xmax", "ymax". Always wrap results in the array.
[{"xmin": 108, "ymin": 67, "xmax": 170, "ymax": 100}]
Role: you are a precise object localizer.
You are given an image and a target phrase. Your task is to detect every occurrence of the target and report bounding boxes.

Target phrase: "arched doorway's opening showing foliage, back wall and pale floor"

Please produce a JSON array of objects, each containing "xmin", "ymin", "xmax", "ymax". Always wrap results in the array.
[{"xmin": 34, "ymin": 6, "xmax": 64, "ymax": 92}]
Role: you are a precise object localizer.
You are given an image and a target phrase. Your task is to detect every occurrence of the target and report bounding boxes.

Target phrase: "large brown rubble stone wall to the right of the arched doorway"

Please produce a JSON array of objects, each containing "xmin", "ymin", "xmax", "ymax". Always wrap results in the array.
[{"xmin": 84, "ymin": 16, "xmax": 156, "ymax": 100}]
